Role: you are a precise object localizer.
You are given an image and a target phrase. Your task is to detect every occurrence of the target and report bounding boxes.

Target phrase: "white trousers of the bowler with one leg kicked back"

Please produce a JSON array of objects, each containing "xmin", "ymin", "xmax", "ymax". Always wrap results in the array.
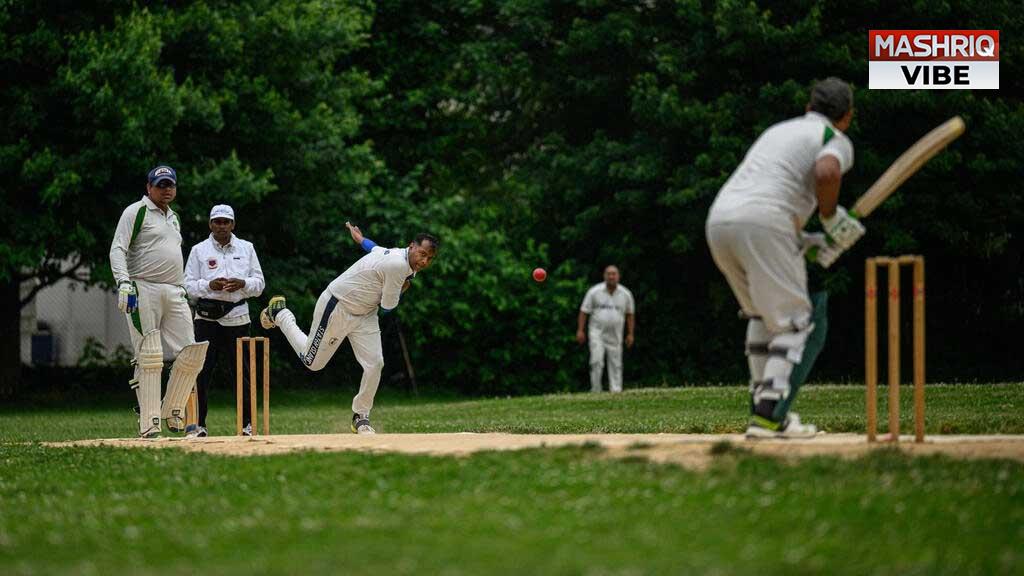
[{"xmin": 274, "ymin": 290, "xmax": 384, "ymax": 416}]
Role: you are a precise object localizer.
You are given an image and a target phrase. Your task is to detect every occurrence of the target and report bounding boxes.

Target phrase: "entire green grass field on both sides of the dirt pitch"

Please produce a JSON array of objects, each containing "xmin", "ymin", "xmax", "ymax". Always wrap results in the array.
[{"xmin": 0, "ymin": 384, "xmax": 1024, "ymax": 575}]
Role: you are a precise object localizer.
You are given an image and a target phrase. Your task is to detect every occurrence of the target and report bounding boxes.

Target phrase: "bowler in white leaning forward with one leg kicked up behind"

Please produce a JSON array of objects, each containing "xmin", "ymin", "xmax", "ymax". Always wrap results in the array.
[{"xmin": 260, "ymin": 222, "xmax": 437, "ymax": 434}]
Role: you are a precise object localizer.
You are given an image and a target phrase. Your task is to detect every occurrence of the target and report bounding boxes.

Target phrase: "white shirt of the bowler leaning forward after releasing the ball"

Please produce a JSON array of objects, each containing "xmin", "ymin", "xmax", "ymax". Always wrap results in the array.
[{"xmin": 327, "ymin": 246, "xmax": 413, "ymax": 316}]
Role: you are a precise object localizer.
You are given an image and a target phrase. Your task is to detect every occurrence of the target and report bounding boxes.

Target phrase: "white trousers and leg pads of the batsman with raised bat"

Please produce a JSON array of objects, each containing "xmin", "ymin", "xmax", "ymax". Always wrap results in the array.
[{"xmin": 707, "ymin": 215, "xmax": 813, "ymax": 403}]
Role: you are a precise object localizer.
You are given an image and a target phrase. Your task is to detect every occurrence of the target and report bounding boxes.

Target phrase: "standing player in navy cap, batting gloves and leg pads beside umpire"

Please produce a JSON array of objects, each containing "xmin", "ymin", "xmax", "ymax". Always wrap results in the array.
[{"xmin": 111, "ymin": 166, "xmax": 207, "ymax": 438}]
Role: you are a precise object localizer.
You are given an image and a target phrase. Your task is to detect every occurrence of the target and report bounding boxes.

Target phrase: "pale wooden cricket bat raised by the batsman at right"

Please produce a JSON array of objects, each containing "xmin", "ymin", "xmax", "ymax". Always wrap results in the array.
[{"xmin": 850, "ymin": 116, "xmax": 966, "ymax": 218}]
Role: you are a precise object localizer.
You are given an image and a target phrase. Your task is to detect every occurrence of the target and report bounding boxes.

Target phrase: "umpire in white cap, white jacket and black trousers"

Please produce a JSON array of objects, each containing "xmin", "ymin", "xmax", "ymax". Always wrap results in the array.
[{"xmin": 185, "ymin": 204, "xmax": 265, "ymax": 438}]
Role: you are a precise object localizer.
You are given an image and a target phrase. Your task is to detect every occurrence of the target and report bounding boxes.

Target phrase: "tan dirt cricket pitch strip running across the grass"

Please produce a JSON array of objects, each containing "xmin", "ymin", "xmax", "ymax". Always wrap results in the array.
[{"xmin": 54, "ymin": 433, "xmax": 1024, "ymax": 469}]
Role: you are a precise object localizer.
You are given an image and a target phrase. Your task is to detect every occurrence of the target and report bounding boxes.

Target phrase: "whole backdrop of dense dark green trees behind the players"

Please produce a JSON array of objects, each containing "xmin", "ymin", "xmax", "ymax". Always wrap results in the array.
[{"xmin": 0, "ymin": 0, "xmax": 1024, "ymax": 394}]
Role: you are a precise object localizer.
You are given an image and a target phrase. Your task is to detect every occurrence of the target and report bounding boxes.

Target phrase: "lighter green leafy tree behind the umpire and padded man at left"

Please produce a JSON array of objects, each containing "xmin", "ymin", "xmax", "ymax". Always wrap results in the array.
[{"xmin": 0, "ymin": 0, "xmax": 382, "ymax": 390}]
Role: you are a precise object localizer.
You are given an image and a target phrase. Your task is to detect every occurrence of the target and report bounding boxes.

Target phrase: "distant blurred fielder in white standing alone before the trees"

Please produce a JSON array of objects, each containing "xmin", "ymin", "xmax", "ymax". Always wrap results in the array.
[{"xmin": 577, "ymin": 265, "xmax": 636, "ymax": 393}]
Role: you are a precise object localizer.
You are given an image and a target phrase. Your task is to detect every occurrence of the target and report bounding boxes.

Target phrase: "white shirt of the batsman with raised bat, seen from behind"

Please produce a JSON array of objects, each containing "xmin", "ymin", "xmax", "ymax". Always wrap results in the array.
[{"xmin": 708, "ymin": 112, "xmax": 853, "ymax": 233}]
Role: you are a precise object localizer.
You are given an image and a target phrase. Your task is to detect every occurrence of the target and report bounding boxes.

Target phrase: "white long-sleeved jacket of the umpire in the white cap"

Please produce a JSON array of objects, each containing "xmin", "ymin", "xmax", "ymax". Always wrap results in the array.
[{"xmin": 185, "ymin": 234, "xmax": 266, "ymax": 326}]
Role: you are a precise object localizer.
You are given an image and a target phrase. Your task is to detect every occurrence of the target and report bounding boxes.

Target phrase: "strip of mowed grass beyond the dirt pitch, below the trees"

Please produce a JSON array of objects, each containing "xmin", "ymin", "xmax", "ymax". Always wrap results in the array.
[{"xmin": 0, "ymin": 383, "xmax": 1024, "ymax": 441}]
